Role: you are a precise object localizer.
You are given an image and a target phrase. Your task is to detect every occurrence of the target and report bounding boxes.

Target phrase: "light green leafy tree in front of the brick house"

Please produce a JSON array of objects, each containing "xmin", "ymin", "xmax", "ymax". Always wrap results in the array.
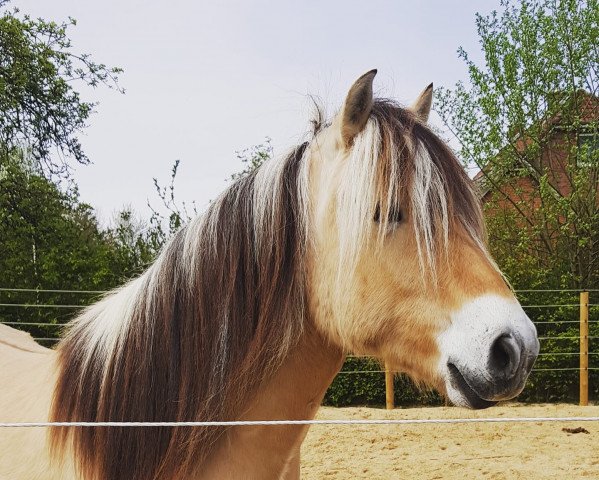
[{"xmin": 437, "ymin": 0, "xmax": 599, "ymax": 288}]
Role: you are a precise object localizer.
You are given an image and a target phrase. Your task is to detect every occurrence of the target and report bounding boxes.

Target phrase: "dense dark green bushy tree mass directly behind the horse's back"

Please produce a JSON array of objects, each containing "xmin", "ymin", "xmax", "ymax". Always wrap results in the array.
[{"xmin": 0, "ymin": 150, "xmax": 171, "ymax": 338}]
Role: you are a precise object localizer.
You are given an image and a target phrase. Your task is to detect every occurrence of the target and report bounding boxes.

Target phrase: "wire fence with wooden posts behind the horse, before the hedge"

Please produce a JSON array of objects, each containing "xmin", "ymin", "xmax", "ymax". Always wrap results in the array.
[{"xmin": 0, "ymin": 288, "xmax": 599, "ymax": 409}]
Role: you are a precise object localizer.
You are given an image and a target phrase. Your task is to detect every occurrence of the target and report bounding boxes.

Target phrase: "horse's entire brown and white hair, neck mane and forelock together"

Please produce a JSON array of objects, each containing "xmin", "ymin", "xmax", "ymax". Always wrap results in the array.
[{"xmin": 50, "ymin": 99, "xmax": 484, "ymax": 480}]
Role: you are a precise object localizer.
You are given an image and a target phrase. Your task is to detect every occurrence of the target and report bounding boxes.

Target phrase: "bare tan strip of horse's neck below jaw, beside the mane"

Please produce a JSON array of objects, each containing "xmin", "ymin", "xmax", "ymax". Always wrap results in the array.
[{"xmin": 202, "ymin": 327, "xmax": 344, "ymax": 479}]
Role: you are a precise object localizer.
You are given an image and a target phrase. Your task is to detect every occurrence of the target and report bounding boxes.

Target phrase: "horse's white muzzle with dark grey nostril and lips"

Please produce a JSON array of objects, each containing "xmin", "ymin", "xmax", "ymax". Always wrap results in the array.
[{"xmin": 437, "ymin": 295, "xmax": 539, "ymax": 408}]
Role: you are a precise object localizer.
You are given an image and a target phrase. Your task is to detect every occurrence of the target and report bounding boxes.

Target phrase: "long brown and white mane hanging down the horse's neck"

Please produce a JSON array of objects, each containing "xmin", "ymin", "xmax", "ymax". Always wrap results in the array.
[{"xmin": 51, "ymin": 144, "xmax": 308, "ymax": 480}]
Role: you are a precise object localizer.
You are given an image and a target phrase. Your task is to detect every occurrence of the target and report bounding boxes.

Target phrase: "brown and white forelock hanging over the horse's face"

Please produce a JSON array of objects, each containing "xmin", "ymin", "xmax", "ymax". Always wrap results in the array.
[{"xmin": 337, "ymin": 99, "xmax": 490, "ymax": 284}]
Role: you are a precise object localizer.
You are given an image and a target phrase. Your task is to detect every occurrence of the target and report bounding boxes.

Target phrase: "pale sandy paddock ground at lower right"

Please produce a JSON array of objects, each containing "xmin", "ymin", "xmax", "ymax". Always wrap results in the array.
[{"xmin": 301, "ymin": 404, "xmax": 599, "ymax": 480}]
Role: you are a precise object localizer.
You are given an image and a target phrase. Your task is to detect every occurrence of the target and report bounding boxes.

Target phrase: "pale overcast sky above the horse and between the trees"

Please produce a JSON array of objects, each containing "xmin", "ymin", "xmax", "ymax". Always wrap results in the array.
[{"xmin": 12, "ymin": 0, "xmax": 499, "ymax": 221}]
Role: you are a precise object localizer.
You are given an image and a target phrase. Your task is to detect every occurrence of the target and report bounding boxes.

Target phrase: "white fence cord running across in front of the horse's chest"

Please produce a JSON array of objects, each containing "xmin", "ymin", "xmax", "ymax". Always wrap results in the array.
[{"xmin": 0, "ymin": 416, "xmax": 599, "ymax": 428}]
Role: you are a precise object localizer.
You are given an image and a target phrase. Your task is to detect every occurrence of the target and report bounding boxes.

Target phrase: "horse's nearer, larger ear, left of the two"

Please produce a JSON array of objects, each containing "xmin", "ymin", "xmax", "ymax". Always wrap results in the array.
[{"xmin": 341, "ymin": 69, "xmax": 376, "ymax": 147}]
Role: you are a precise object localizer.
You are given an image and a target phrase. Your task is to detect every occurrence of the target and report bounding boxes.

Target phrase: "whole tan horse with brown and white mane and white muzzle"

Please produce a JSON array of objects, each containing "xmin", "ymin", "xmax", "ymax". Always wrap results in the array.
[{"xmin": 0, "ymin": 70, "xmax": 539, "ymax": 480}]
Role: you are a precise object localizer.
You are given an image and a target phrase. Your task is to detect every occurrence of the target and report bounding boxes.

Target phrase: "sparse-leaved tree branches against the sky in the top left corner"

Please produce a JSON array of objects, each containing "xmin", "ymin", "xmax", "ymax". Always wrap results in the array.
[{"xmin": 0, "ymin": 0, "xmax": 122, "ymax": 177}]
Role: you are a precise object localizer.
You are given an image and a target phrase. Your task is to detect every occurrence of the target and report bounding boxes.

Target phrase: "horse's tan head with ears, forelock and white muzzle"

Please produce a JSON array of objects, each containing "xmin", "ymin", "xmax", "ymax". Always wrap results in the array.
[{"xmin": 307, "ymin": 70, "xmax": 539, "ymax": 408}]
